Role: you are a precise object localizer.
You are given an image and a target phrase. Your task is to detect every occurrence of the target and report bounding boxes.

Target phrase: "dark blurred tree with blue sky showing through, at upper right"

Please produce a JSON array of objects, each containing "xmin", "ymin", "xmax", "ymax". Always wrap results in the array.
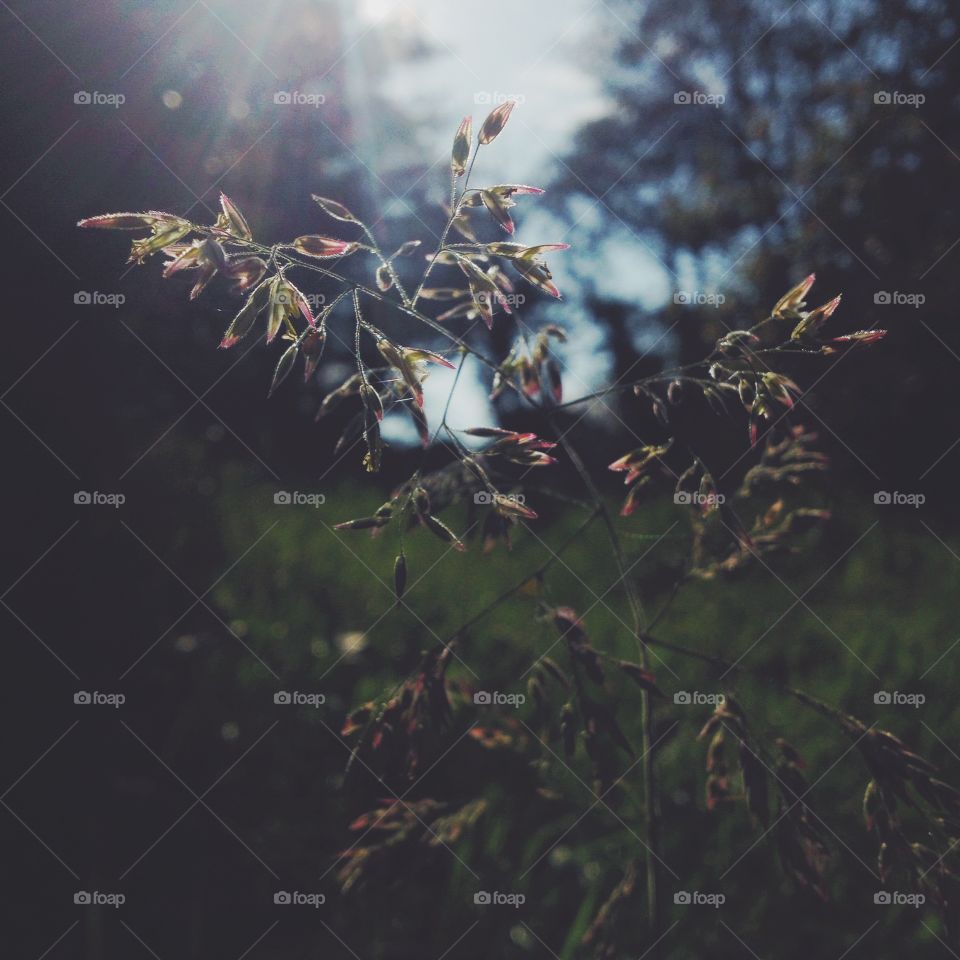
[{"xmin": 551, "ymin": 0, "xmax": 960, "ymax": 489}]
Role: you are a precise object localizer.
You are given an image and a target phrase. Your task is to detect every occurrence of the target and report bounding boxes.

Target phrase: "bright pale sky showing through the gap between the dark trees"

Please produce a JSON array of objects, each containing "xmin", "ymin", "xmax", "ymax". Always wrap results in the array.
[{"xmin": 344, "ymin": 0, "xmax": 672, "ymax": 440}]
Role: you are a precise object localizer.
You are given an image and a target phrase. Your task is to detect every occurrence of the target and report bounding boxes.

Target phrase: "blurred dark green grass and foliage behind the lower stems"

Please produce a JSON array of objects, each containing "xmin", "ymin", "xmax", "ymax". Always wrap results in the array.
[{"xmin": 188, "ymin": 462, "xmax": 957, "ymax": 958}]
